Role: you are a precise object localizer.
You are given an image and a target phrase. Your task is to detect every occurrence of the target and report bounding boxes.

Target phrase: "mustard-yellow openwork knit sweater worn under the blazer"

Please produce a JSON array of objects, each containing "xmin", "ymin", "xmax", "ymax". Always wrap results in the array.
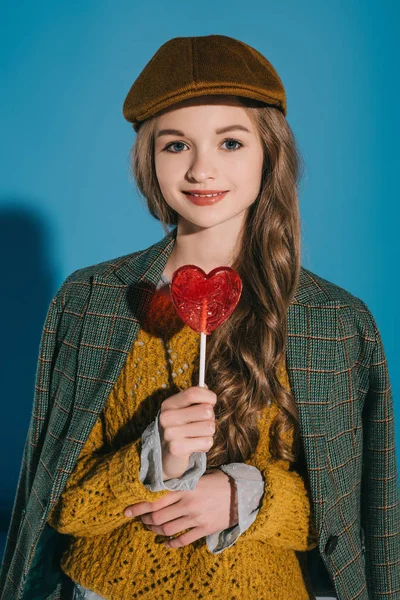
[{"xmin": 48, "ymin": 288, "xmax": 317, "ymax": 600}]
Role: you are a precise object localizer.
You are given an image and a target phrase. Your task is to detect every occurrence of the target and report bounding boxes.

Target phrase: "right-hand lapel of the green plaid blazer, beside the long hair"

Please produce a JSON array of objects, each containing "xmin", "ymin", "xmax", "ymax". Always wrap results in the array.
[{"xmin": 286, "ymin": 292, "xmax": 338, "ymax": 535}]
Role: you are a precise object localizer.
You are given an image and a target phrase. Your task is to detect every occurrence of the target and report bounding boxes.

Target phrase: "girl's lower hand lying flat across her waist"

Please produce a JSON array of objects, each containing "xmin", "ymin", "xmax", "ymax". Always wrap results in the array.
[{"xmin": 124, "ymin": 469, "xmax": 239, "ymax": 548}]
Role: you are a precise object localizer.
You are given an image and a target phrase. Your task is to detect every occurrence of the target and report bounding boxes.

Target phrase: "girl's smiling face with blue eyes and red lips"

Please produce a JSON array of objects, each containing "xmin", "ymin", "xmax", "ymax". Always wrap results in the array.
[{"xmin": 154, "ymin": 96, "xmax": 263, "ymax": 232}]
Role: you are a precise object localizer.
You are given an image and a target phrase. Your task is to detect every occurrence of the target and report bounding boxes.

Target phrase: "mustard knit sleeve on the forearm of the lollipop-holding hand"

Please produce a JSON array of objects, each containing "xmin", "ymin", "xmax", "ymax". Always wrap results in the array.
[{"xmin": 47, "ymin": 415, "xmax": 169, "ymax": 537}]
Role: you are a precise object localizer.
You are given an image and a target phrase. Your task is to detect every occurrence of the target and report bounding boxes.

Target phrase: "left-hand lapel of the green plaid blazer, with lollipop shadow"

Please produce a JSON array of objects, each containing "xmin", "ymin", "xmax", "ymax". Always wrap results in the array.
[{"xmin": 49, "ymin": 230, "xmax": 175, "ymax": 506}]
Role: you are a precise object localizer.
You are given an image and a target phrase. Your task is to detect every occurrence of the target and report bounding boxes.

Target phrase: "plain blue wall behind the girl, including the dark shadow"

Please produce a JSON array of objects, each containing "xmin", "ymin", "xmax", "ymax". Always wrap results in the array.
[{"xmin": 0, "ymin": 0, "xmax": 400, "ymax": 556}]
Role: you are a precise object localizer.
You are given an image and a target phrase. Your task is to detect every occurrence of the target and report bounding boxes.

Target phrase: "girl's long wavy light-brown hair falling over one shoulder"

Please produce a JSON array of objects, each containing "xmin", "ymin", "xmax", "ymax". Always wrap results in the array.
[{"xmin": 130, "ymin": 97, "xmax": 303, "ymax": 471}]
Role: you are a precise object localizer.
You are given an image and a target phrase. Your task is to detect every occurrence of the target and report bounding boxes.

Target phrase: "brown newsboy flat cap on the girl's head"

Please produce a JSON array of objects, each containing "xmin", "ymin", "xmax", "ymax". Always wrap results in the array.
[{"xmin": 123, "ymin": 35, "xmax": 287, "ymax": 131}]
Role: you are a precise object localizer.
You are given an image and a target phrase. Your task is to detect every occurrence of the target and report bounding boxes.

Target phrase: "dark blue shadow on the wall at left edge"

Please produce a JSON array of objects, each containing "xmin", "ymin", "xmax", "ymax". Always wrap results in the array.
[{"xmin": 0, "ymin": 202, "xmax": 57, "ymax": 562}]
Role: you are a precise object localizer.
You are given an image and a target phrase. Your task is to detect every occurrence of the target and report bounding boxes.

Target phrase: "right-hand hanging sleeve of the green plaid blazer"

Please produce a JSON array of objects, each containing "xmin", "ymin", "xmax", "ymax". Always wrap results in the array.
[{"xmin": 361, "ymin": 308, "xmax": 400, "ymax": 600}]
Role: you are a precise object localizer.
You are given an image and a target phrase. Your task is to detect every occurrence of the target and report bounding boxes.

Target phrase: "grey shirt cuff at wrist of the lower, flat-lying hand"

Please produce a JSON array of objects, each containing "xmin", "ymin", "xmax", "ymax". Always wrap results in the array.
[{"xmin": 206, "ymin": 463, "xmax": 265, "ymax": 554}]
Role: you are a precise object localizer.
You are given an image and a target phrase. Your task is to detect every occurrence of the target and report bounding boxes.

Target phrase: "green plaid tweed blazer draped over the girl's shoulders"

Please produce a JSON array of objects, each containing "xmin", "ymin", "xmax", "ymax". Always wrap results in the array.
[{"xmin": 0, "ymin": 229, "xmax": 400, "ymax": 600}]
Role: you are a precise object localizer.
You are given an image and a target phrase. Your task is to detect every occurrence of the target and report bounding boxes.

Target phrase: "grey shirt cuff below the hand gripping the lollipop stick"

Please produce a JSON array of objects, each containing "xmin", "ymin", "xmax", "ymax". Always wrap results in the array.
[{"xmin": 139, "ymin": 411, "xmax": 207, "ymax": 492}]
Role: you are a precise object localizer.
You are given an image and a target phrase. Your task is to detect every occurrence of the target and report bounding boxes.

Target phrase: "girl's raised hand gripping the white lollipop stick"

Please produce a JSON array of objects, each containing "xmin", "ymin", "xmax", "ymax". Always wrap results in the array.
[{"xmin": 159, "ymin": 386, "xmax": 217, "ymax": 481}]
